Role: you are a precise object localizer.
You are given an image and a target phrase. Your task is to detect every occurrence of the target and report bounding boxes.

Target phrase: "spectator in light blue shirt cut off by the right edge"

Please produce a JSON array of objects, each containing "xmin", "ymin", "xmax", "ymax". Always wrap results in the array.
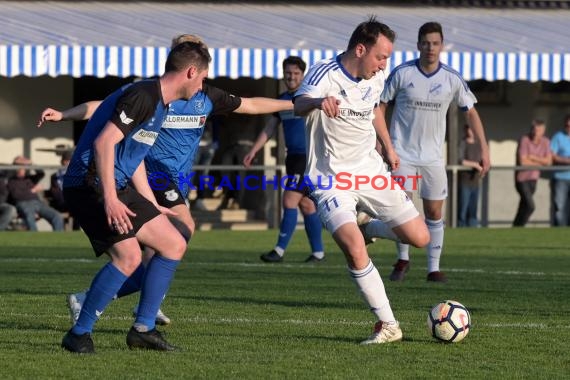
[{"xmin": 550, "ymin": 115, "xmax": 570, "ymax": 226}]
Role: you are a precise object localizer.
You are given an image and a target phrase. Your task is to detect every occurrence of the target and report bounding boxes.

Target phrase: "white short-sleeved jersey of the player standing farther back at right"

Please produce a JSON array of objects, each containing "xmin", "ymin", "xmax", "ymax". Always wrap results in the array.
[{"xmin": 380, "ymin": 59, "xmax": 477, "ymax": 166}]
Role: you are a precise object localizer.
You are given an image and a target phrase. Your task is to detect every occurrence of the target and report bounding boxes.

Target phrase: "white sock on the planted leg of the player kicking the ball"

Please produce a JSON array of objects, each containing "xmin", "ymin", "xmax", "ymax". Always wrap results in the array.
[{"xmin": 348, "ymin": 261, "xmax": 396, "ymax": 322}]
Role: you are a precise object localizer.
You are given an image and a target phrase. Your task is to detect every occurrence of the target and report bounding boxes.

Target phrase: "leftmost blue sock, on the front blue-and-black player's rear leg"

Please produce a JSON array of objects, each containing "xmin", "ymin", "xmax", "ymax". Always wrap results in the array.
[{"xmin": 71, "ymin": 263, "xmax": 127, "ymax": 335}]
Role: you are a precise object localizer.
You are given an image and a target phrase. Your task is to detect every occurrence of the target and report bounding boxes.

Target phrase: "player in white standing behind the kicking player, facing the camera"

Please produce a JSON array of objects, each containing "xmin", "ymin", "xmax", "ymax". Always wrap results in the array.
[{"xmin": 366, "ymin": 22, "xmax": 490, "ymax": 282}]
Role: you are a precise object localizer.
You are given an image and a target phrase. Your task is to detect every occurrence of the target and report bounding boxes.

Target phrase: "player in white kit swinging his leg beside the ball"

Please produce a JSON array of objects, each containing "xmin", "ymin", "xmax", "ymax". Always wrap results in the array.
[{"xmin": 294, "ymin": 17, "xmax": 429, "ymax": 344}]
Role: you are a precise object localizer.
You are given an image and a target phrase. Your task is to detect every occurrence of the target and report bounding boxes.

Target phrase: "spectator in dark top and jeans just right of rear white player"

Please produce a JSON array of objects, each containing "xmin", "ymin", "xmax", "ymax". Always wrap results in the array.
[{"xmin": 457, "ymin": 124, "xmax": 483, "ymax": 227}]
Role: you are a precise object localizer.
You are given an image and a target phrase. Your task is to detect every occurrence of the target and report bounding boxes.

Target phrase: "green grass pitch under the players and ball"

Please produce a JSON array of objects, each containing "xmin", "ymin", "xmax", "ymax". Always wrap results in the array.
[{"xmin": 0, "ymin": 229, "xmax": 570, "ymax": 379}]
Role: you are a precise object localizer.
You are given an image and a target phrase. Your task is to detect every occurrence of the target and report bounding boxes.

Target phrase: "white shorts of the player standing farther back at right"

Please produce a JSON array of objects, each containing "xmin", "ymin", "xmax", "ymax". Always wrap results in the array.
[{"xmin": 392, "ymin": 163, "xmax": 447, "ymax": 201}]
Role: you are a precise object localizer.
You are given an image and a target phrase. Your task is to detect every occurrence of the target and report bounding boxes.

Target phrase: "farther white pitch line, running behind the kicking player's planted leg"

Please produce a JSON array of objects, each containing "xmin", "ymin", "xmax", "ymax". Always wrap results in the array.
[{"xmin": 0, "ymin": 257, "xmax": 570, "ymax": 277}]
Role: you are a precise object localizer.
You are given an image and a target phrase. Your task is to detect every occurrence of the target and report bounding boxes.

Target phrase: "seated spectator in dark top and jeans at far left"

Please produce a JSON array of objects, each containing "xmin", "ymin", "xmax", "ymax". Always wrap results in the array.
[{"xmin": 8, "ymin": 156, "xmax": 63, "ymax": 231}]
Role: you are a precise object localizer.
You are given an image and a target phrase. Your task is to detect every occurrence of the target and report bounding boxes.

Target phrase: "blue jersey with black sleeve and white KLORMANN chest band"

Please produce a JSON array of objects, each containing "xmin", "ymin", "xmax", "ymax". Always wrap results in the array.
[{"xmin": 145, "ymin": 84, "xmax": 241, "ymax": 196}]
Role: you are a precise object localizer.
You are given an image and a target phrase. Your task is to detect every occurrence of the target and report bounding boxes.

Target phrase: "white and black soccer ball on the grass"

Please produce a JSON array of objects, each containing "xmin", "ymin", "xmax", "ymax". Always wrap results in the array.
[{"xmin": 427, "ymin": 300, "xmax": 471, "ymax": 343}]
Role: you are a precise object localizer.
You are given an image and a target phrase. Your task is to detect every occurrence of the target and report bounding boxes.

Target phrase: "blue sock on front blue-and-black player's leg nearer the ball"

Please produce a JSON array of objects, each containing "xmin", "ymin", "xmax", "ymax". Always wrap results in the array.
[{"xmin": 135, "ymin": 255, "xmax": 180, "ymax": 331}]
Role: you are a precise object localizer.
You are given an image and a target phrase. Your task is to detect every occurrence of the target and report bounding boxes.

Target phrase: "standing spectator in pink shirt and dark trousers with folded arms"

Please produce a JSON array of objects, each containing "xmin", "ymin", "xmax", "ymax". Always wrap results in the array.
[{"xmin": 513, "ymin": 119, "xmax": 552, "ymax": 227}]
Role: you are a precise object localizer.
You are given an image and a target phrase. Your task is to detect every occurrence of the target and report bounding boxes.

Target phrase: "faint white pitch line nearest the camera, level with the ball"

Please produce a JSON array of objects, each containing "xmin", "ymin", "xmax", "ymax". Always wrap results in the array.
[{"xmin": 4, "ymin": 312, "xmax": 570, "ymax": 330}]
